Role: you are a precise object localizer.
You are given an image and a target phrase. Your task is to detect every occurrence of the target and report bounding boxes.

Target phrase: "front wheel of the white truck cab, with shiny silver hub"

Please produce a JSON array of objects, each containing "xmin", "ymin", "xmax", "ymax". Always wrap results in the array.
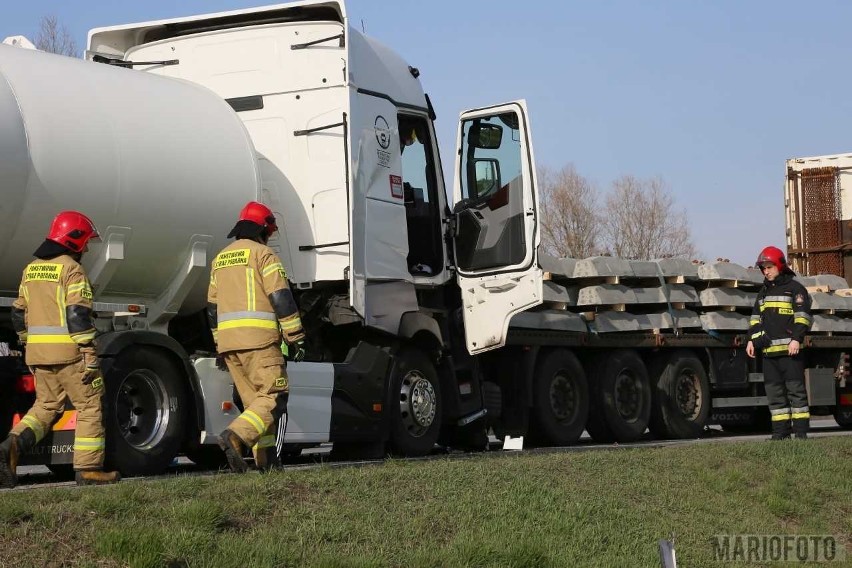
[{"xmin": 389, "ymin": 349, "xmax": 442, "ymax": 456}]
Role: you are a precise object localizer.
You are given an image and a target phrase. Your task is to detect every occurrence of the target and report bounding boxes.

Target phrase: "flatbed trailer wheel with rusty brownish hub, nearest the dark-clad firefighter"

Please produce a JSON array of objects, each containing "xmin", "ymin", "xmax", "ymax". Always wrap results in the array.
[{"xmin": 648, "ymin": 350, "xmax": 711, "ymax": 440}]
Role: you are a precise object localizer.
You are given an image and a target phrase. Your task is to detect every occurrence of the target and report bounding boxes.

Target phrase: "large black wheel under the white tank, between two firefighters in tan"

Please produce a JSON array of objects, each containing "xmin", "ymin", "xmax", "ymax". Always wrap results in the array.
[{"xmin": 103, "ymin": 346, "xmax": 190, "ymax": 475}]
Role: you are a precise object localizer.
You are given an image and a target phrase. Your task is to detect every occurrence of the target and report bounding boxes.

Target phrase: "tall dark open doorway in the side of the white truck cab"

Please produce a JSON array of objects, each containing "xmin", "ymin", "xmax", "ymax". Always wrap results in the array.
[{"xmin": 398, "ymin": 115, "xmax": 444, "ymax": 276}]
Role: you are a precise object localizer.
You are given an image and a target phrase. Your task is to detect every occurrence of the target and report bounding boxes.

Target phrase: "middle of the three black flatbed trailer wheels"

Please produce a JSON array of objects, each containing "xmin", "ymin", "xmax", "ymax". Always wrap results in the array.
[{"xmin": 586, "ymin": 349, "xmax": 652, "ymax": 443}]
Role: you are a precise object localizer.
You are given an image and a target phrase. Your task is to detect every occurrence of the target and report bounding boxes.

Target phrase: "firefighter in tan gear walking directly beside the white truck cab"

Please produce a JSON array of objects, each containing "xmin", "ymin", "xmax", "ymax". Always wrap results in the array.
[{"xmin": 207, "ymin": 201, "xmax": 305, "ymax": 472}]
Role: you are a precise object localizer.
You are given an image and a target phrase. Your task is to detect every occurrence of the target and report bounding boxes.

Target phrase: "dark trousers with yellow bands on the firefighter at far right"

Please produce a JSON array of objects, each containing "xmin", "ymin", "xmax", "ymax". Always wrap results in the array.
[{"xmin": 763, "ymin": 356, "xmax": 811, "ymax": 438}]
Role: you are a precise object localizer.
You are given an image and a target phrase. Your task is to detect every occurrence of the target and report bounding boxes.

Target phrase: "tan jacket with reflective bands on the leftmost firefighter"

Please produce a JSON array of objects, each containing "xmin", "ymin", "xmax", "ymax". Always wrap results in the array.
[{"xmin": 12, "ymin": 254, "xmax": 95, "ymax": 366}]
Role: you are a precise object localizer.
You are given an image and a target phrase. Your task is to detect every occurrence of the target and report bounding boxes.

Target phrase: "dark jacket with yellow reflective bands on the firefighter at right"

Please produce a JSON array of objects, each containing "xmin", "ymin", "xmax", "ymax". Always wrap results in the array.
[{"xmin": 749, "ymin": 270, "xmax": 812, "ymax": 357}]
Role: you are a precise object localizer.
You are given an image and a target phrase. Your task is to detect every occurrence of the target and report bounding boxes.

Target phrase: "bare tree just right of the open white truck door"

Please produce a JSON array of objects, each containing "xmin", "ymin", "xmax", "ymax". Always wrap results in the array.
[{"xmin": 538, "ymin": 164, "xmax": 600, "ymax": 258}]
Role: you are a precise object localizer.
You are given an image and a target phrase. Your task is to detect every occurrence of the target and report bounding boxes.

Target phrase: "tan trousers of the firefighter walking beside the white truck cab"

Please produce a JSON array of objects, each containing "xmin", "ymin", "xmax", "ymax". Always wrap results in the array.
[{"xmin": 223, "ymin": 345, "xmax": 289, "ymax": 455}]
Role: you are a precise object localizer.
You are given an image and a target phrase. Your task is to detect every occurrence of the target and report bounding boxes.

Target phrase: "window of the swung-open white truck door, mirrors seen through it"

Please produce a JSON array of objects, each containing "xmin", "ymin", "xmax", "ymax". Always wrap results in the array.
[{"xmin": 455, "ymin": 112, "xmax": 526, "ymax": 270}]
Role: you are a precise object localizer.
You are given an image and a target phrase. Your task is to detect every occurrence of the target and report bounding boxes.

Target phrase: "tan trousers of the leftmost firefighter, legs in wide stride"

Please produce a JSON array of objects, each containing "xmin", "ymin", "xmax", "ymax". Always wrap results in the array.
[{"xmin": 11, "ymin": 359, "xmax": 106, "ymax": 471}]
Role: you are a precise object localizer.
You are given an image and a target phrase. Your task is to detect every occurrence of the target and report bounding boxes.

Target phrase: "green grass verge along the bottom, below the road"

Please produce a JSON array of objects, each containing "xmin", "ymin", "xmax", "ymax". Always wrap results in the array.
[{"xmin": 0, "ymin": 437, "xmax": 852, "ymax": 567}]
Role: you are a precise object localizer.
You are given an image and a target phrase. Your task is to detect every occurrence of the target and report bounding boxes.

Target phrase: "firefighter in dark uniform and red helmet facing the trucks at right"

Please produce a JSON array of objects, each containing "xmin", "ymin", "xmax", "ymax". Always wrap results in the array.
[{"xmin": 746, "ymin": 247, "xmax": 812, "ymax": 440}]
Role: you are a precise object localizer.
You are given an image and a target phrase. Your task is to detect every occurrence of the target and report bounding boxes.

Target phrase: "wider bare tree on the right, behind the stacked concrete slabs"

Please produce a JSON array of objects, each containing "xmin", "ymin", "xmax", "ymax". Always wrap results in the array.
[{"xmin": 601, "ymin": 176, "xmax": 696, "ymax": 260}]
